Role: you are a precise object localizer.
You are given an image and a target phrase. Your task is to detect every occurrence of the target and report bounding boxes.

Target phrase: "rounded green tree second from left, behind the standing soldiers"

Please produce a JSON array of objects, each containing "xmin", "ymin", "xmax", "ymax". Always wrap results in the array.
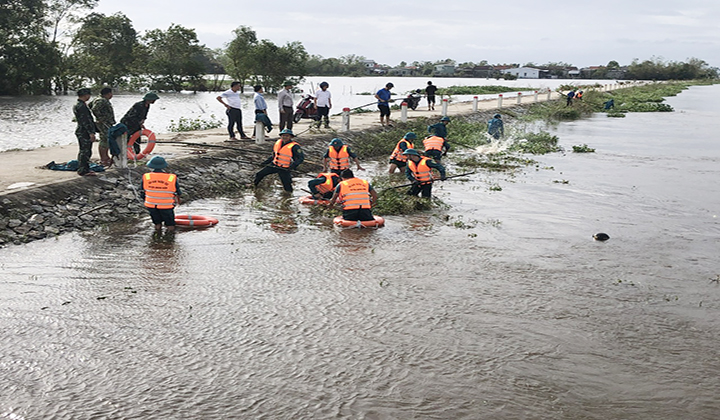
[{"xmin": 71, "ymin": 13, "xmax": 139, "ymax": 86}]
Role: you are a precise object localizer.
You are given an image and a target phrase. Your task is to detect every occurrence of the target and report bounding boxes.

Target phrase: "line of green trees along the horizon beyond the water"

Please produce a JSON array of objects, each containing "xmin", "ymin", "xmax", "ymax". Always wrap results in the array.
[{"xmin": 0, "ymin": 0, "xmax": 718, "ymax": 95}]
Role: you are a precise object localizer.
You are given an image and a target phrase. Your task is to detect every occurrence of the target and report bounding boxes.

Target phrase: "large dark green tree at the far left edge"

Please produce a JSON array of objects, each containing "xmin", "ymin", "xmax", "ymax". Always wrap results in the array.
[{"xmin": 0, "ymin": 0, "xmax": 58, "ymax": 95}]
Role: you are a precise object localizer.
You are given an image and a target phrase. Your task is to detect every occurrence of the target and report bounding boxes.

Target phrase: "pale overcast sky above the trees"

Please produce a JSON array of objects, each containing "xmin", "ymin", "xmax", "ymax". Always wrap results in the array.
[{"xmin": 95, "ymin": 0, "xmax": 720, "ymax": 67}]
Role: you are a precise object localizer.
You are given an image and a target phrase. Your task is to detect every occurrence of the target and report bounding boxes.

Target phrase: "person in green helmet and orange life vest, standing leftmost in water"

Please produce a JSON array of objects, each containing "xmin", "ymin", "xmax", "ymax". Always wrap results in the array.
[{"xmin": 140, "ymin": 156, "xmax": 182, "ymax": 232}]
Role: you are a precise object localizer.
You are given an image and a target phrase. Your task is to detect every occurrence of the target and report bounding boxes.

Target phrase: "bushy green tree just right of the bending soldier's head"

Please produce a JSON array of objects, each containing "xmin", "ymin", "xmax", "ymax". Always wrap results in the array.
[{"xmin": 143, "ymin": 24, "xmax": 205, "ymax": 92}]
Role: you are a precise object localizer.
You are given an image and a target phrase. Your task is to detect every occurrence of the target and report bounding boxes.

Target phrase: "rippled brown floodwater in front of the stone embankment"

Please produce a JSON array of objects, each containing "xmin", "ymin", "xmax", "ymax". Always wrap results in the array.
[{"xmin": 0, "ymin": 86, "xmax": 720, "ymax": 420}]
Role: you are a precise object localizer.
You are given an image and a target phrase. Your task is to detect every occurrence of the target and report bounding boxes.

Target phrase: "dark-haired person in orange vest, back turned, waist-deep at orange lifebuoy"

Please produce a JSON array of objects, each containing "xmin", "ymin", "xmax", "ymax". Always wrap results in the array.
[{"xmin": 329, "ymin": 169, "xmax": 377, "ymax": 222}]
